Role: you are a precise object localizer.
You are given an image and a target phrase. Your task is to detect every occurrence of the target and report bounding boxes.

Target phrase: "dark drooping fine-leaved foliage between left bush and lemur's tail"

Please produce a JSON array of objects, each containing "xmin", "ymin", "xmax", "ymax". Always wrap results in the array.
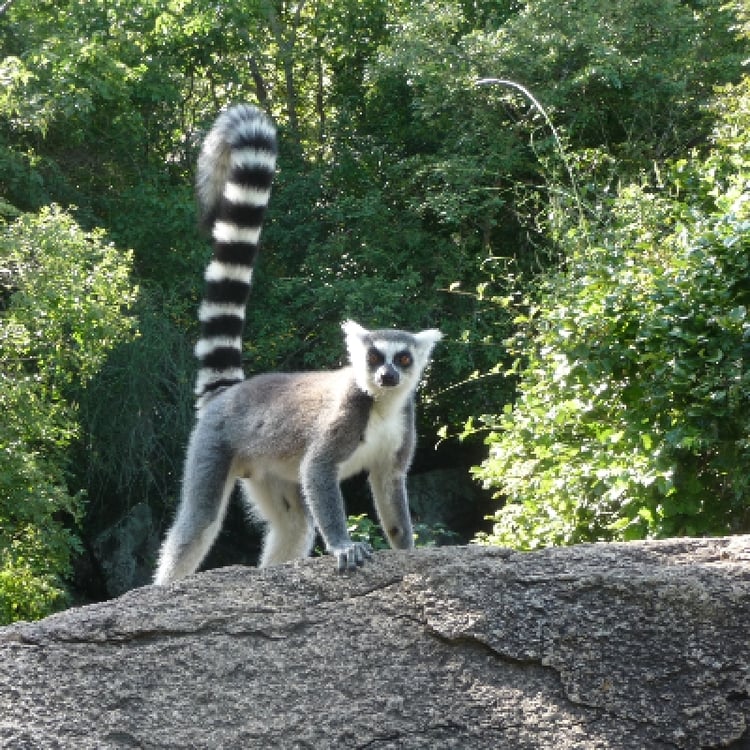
[{"xmin": 76, "ymin": 289, "xmax": 195, "ymax": 533}]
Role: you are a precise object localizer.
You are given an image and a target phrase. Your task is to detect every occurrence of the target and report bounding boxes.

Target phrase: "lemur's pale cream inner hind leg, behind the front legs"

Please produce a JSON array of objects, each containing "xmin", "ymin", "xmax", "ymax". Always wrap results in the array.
[{"xmin": 242, "ymin": 477, "xmax": 315, "ymax": 567}]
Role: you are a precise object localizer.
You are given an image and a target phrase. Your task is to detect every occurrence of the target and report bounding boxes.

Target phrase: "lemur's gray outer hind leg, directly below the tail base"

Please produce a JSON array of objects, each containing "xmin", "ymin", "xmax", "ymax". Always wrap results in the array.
[{"xmin": 154, "ymin": 432, "xmax": 236, "ymax": 585}]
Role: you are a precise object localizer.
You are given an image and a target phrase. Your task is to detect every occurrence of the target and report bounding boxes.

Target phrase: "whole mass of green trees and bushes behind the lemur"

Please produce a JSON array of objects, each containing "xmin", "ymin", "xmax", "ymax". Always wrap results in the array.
[{"xmin": 0, "ymin": 0, "xmax": 750, "ymax": 621}]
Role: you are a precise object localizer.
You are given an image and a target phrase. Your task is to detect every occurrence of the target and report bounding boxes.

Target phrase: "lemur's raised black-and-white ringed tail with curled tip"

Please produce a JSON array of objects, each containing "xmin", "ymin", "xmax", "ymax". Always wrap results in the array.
[{"xmin": 195, "ymin": 104, "xmax": 276, "ymax": 410}]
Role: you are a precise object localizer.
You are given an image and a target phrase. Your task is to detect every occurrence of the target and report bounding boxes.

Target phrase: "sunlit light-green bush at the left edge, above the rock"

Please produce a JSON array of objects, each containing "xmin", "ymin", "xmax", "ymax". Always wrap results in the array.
[{"xmin": 0, "ymin": 207, "xmax": 135, "ymax": 623}]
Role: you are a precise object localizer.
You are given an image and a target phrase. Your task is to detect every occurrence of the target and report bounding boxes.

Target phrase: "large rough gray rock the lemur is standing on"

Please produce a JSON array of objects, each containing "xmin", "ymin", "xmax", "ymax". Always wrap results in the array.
[{"xmin": 0, "ymin": 537, "xmax": 750, "ymax": 750}]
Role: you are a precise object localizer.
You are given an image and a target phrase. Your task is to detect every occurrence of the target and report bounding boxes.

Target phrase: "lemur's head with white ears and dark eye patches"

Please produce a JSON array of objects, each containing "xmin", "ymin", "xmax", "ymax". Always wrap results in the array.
[{"xmin": 342, "ymin": 320, "xmax": 442, "ymax": 398}]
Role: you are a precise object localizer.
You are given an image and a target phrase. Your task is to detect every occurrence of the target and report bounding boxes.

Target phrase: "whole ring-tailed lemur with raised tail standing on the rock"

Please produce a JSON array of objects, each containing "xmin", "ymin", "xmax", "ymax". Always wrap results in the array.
[{"xmin": 154, "ymin": 105, "xmax": 441, "ymax": 584}]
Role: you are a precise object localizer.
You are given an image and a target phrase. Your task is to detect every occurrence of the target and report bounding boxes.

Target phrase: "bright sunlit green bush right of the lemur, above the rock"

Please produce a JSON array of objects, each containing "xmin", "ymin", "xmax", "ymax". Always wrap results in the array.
[{"xmin": 476, "ymin": 81, "xmax": 750, "ymax": 548}]
